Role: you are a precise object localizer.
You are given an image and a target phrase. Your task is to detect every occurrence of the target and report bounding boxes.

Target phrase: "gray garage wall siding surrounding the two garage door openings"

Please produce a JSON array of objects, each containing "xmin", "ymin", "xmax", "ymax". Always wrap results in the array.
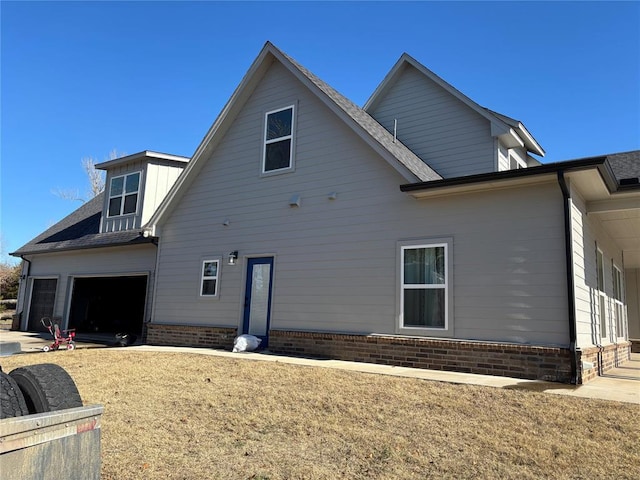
[{"xmin": 23, "ymin": 245, "xmax": 156, "ymax": 328}]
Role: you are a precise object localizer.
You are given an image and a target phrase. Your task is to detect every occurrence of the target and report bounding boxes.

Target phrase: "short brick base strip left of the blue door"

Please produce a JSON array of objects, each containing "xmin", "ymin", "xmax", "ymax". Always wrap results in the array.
[{"xmin": 146, "ymin": 323, "xmax": 237, "ymax": 350}]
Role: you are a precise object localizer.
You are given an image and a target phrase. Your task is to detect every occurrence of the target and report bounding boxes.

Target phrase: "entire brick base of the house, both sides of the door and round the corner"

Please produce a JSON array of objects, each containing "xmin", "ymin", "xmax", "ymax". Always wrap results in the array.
[{"xmin": 146, "ymin": 323, "xmax": 631, "ymax": 383}]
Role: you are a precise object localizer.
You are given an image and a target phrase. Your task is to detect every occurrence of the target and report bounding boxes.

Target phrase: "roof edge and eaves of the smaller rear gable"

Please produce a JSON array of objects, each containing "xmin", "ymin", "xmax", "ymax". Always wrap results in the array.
[{"xmin": 364, "ymin": 53, "xmax": 544, "ymax": 156}]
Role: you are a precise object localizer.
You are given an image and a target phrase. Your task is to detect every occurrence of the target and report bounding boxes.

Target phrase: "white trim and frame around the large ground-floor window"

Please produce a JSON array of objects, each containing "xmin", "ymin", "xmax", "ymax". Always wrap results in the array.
[{"xmin": 396, "ymin": 237, "xmax": 453, "ymax": 337}]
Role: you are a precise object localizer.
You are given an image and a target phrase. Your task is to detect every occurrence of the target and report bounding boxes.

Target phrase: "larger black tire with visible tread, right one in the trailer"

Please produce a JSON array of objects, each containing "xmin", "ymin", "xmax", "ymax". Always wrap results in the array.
[{"xmin": 9, "ymin": 363, "xmax": 82, "ymax": 413}]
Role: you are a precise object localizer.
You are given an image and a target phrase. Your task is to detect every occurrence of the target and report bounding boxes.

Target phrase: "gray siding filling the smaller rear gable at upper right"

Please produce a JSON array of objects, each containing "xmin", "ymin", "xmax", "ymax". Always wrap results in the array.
[{"xmin": 369, "ymin": 65, "xmax": 497, "ymax": 178}]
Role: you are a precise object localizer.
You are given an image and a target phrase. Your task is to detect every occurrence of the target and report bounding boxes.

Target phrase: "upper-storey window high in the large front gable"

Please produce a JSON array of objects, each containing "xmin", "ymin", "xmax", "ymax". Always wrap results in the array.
[{"xmin": 262, "ymin": 105, "xmax": 293, "ymax": 173}]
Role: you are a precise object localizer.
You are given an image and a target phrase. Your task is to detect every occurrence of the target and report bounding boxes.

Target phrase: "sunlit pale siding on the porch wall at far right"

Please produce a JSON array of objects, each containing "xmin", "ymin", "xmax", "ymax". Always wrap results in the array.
[{"xmin": 571, "ymin": 188, "xmax": 624, "ymax": 348}]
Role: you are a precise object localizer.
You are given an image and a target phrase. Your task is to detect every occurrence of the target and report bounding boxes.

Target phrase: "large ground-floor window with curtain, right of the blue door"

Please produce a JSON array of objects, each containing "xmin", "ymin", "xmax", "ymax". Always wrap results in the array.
[{"xmin": 400, "ymin": 244, "xmax": 449, "ymax": 329}]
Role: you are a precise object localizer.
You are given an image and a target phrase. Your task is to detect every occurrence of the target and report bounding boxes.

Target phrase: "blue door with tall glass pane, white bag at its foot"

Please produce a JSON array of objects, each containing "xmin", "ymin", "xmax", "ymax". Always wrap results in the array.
[{"xmin": 242, "ymin": 257, "xmax": 273, "ymax": 348}]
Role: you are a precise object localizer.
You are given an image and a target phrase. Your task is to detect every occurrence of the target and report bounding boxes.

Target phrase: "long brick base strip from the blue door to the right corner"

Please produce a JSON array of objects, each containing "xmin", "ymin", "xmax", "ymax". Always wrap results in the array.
[{"xmin": 269, "ymin": 330, "xmax": 571, "ymax": 383}]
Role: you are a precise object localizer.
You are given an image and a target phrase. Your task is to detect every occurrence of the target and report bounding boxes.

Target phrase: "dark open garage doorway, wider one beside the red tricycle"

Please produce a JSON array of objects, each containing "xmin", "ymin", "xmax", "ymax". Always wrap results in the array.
[{"xmin": 69, "ymin": 275, "xmax": 147, "ymax": 335}]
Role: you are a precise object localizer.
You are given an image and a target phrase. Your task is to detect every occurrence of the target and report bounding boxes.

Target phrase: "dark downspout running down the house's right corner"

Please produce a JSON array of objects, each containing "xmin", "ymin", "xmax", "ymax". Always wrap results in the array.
[{"xmin": 558, "ymin": 170, "xmax": 578, "ymax": 385}]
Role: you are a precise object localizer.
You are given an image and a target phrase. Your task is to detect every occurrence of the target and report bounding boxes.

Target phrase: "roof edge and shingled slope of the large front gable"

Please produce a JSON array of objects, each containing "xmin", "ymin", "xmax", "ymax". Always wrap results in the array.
[{"xmin": 149, "ymin": 42, "xmax": 442, "ymax": 229}]
